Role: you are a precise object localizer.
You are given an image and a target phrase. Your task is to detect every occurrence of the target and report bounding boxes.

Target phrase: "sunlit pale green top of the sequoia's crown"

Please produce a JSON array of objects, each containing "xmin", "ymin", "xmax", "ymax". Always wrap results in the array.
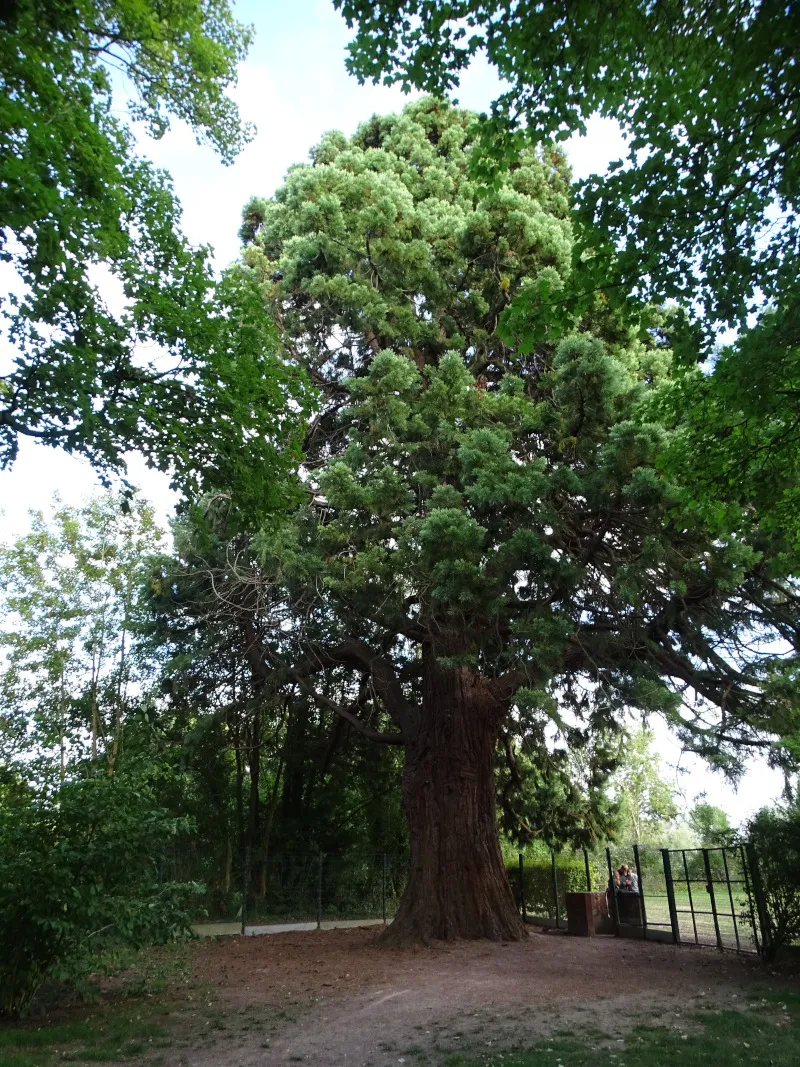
[{"xmin": 241, "ymin": 101, "xmax": 572, "ymax": 367}]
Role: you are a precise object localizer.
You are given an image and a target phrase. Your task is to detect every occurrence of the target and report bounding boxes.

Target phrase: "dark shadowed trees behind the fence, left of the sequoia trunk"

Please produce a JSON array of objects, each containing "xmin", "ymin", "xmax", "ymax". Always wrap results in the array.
[{"xmin": 139, "ymin": 503, "xmax": 405, "ymax": 908}]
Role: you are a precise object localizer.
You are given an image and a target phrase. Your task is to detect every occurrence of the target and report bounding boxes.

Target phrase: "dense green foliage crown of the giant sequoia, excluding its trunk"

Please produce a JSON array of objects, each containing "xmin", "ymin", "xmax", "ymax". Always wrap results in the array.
[{"xmin": 243, "ymin": 100, "xmax": 797, "ymax": 772}]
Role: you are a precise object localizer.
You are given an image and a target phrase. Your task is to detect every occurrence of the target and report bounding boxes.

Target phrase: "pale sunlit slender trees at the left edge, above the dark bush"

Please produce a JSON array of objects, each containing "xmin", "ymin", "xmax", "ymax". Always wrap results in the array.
[{"xmin": 0, "ymin": 495, "xmax": 162, "ymax": 780}]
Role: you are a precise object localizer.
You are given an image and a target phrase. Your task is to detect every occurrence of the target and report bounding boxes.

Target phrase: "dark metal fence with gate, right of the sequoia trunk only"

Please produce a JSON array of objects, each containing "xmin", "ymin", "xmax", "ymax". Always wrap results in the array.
[{"xmin": 510, "ymin": 845, "xmax": 768, "ymax": 953}]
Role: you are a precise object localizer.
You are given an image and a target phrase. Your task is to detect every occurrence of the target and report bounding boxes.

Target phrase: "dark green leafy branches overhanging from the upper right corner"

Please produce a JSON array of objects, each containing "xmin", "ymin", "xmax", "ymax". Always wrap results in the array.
[{"xmin": 336, "ymin": 0, "xmax": 800, "ymax": 543}]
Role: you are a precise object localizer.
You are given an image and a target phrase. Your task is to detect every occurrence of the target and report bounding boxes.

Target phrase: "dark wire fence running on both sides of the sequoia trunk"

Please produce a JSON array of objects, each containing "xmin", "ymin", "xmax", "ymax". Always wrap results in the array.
[{"xmin": 161, "ymin": 844, "xmax": 766, "ymax": 953}]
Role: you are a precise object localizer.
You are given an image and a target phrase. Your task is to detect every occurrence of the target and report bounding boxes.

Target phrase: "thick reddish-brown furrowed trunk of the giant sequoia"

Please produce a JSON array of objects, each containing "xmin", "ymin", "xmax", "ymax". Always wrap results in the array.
[{"xmin": 382, "ymin": 650, "xmax": 526, "ymax": 945}]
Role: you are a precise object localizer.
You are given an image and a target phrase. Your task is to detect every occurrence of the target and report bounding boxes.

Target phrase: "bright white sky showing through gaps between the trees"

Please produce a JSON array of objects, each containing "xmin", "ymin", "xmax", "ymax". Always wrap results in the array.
[{"xmin": 0, "ymin": 0, "xmax": 783, "ymax": 823}]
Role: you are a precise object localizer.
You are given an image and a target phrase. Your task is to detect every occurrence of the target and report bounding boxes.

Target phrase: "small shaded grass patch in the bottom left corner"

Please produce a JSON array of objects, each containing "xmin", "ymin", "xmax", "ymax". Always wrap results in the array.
[{"xmin": 0, "ymin": 1014, "xmax": 165, "ymax": 1067}]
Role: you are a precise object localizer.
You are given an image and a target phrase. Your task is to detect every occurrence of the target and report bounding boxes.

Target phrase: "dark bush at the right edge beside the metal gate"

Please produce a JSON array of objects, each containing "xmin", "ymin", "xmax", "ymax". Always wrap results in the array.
[{"xmin": 747, "ymin": 800, "xmax": 800, "ymax": 954}]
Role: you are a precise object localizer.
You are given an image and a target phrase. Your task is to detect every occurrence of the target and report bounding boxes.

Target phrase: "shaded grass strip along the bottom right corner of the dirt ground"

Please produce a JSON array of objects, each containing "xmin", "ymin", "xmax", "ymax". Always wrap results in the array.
[{"xmin": 456, "ymin": 990, "xmax": 800, "ymax": 1067}]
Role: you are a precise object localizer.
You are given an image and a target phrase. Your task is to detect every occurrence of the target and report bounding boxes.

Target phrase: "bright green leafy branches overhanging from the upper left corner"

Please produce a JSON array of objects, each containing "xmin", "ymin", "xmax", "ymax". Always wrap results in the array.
[{"xmin": 0, "ymin": 0, "xmax": 307, "ymax": 505}]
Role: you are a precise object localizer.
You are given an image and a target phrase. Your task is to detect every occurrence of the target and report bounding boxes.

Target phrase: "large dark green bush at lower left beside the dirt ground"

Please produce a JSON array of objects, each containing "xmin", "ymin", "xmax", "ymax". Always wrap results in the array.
[{"xmin": 0, "ymin": 776, "xmax": 199, "ymax": 1017}]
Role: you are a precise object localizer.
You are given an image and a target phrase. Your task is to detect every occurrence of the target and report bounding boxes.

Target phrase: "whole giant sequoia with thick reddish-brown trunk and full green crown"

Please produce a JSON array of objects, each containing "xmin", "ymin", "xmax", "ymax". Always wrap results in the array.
[{"xmin": 237, "ymin": 99, "xmax": 798, "ymax": 942}]
